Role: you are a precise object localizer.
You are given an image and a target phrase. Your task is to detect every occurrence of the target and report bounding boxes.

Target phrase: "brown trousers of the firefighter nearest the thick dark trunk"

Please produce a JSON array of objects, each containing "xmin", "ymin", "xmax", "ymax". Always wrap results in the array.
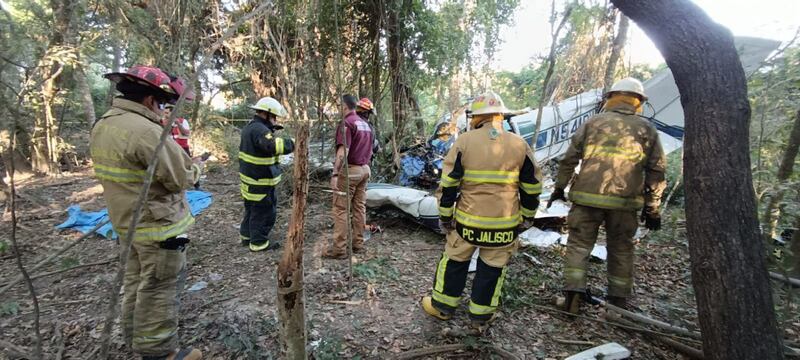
[{"xmin": 564, "ymin": 205, "xmax": 639, "ymax": 297}]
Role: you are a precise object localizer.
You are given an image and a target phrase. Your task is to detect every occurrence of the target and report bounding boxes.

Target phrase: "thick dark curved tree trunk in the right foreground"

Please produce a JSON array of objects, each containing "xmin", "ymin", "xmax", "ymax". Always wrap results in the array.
[{"xmin": 612, "ymin": 0, "xmax": 783, "ymax": 359}]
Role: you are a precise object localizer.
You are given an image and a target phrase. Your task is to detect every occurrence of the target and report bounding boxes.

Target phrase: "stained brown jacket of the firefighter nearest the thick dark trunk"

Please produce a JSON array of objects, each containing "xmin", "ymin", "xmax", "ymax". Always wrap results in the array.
[{"xmin": 556, "ymin": 105, "xmax": 666, "ymax": 210}]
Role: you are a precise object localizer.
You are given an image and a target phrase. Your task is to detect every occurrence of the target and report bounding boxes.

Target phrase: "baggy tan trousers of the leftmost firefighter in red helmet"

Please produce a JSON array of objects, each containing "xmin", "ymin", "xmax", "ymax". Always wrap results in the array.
[{"xmin": 122, "ymin": 242, "xmax": 186, "ymax": 356}]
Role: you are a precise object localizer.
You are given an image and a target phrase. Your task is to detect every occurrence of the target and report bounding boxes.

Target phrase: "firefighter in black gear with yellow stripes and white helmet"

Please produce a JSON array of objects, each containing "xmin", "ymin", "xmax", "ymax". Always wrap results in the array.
[{"xmin": 239, "ymin": 97, "xmax": 294, "ymax": 252}]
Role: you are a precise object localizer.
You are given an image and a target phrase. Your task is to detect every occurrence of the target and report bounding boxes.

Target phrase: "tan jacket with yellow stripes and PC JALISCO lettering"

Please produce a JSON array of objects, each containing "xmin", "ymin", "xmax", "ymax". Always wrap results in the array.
[{"xmin": 439, "ymin": 121, "xmax": 542, "ymax": 247}]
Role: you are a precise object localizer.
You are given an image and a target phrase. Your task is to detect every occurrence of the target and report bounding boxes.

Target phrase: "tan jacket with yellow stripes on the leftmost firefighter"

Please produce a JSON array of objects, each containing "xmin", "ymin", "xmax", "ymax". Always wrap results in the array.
[{"xmin": 90, "ymin": 98, "xmax": 200, "ymax": 241}]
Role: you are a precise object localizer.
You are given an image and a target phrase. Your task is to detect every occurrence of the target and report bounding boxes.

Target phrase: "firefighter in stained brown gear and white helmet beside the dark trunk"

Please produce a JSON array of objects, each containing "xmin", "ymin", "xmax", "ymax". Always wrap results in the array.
[{"xmin": 548, "ymin": 78, "xmax": 666, "ymax": 313}]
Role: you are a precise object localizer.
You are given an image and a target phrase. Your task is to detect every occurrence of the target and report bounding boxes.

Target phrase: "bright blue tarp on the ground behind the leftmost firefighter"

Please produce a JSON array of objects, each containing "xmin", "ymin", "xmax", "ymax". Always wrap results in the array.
[{"xmin": 56, "ymin": 190, "xmax": 213, "ymax": 239}]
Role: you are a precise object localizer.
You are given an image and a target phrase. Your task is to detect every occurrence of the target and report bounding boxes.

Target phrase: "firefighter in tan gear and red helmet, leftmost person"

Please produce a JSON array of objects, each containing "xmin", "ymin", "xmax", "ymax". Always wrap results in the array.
[{"xmin": 90, "ymin": 65, "xmax": 201, "ymax": 360}]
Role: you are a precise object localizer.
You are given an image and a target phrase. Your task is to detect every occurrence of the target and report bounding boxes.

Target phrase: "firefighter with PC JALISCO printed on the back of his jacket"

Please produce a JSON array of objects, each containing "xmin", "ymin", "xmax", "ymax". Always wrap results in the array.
[{"xmin": 422, "ymin": 91, "xmax": 542, "ymax": 330}]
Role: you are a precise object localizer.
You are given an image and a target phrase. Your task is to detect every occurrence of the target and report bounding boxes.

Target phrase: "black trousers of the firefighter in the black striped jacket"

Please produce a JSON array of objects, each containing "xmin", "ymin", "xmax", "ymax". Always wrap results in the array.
[{"xmin": 239, "ymin": 189, "xmax": 278, "ymax": 245}]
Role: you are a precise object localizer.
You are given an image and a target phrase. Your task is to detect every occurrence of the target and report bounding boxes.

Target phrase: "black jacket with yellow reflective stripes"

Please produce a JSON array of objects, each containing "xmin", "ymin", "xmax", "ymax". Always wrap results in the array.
[{"xmin": 239, "ymin": 116, "xmax": 294, "ymax": 201}]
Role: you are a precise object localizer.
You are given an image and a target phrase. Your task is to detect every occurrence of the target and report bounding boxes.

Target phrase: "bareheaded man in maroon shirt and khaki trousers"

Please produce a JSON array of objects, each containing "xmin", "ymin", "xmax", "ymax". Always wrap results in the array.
[{"xmin": 325, "ymin": 95, "xmax": 374, "ymax": 259}]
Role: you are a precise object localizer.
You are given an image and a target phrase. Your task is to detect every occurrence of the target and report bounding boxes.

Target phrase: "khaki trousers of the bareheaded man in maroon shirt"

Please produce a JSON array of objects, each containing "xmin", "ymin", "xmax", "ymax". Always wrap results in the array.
[{"xmin": 330, "ymin": 165, "xmax": 370, "ymax": 255}]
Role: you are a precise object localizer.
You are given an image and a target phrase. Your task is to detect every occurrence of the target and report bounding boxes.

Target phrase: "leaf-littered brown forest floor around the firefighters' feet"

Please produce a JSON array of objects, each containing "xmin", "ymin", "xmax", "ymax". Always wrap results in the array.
[{"xmin": 0, "ymin": 167, "xmax": 800, "ymax": 359}]
